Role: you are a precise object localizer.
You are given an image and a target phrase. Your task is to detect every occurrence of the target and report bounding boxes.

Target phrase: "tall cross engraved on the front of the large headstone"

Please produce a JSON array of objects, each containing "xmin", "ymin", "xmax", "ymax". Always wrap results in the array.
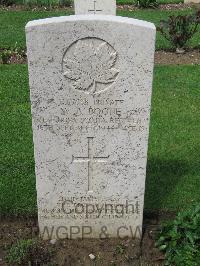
[{"xmin": 72, "ymin": 137, "xmax": 110, "ymax": 192}]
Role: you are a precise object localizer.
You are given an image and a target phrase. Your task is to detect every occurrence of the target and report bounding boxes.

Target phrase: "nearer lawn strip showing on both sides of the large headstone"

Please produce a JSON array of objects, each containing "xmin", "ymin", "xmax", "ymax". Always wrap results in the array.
[{"xmin": 0, "ymin": 65, "xmax": 200, "ymax": 215}]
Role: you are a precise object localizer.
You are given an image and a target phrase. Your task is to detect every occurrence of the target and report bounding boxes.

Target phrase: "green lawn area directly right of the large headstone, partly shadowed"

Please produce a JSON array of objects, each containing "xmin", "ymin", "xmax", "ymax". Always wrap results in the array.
[{"xmin": 145, "ymin": 66, "xmax": 200, "ymax": 209}]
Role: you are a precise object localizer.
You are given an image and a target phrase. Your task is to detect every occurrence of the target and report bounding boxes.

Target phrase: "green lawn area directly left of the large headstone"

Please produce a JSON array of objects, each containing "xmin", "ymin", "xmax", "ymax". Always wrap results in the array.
[{"xmin": 0, "ymin": 65, "xmax": 36, "ymax": 214}]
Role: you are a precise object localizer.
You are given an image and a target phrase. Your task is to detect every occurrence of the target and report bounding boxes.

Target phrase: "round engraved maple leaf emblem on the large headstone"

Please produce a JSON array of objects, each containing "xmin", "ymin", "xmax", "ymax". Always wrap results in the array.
[{"xmin": 63, "ymin": 38, "xmax": 119, "ymax": 94}]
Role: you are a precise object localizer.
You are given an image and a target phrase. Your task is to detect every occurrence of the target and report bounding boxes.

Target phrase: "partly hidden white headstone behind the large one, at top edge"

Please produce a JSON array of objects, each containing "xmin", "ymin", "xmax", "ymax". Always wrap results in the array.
[{"xmin": 74, "ymin": 0, "xmax": 116, "ymax": 15}]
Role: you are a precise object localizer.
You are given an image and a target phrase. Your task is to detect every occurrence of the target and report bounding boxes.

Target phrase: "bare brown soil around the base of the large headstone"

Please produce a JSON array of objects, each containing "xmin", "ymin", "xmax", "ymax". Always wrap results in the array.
[{"xmin": 0, "ymin": 213, "xmax": 174, "ymax": 266}]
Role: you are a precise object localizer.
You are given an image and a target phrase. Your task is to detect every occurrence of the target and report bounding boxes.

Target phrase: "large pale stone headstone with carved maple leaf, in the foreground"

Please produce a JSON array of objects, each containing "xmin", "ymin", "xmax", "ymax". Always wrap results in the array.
[{"xmin": 26, "ymin": 15, "xmax": 155, "ymax": 239}]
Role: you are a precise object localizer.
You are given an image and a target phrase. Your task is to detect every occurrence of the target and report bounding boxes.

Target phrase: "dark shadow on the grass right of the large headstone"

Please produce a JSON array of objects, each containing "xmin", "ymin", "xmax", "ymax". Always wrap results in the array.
[{"xmin": 145, "ymin": 158, "xmax": 192, "ymax": 210}]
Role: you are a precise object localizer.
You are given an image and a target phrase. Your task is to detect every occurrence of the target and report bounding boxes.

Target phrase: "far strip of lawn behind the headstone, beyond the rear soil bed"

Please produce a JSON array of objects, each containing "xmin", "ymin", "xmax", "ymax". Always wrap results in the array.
[{"xmin": 0, "ymin": 9, "xmax": 200, "ymax": 49}]
